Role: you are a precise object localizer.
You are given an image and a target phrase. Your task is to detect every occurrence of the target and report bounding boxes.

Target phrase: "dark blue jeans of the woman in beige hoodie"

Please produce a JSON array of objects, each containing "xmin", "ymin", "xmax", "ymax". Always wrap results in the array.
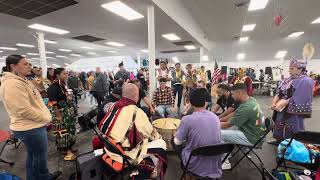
[{"xmin": 13, "ymin": 127, "xmax": 50, "ymax": 180}]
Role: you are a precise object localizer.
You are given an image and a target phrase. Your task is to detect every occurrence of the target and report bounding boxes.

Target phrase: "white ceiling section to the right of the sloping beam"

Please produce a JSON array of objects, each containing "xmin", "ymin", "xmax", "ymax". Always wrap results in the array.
[{"xmin": 180, "ymin": 0, "xmax": 320, "ymax": 61}]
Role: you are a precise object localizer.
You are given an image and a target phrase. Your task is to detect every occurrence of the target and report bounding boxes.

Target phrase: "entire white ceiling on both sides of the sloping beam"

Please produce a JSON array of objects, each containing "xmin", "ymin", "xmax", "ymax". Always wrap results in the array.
[{"xmin": 0, "ymin": 0, "xmax": 320, "ymax": 65}]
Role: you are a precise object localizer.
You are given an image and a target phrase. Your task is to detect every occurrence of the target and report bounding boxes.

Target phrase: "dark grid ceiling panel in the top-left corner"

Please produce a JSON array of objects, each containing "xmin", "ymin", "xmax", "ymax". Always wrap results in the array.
[{"xmin": 0, "ymin": 0, "xmax": 78, "ymax": 19}]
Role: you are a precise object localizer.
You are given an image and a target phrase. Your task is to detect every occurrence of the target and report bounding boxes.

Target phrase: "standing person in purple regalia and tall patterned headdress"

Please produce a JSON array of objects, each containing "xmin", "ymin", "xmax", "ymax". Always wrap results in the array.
[{"xmin": 269, "ymin": 54, "xmax": 313, "ymax": 143}]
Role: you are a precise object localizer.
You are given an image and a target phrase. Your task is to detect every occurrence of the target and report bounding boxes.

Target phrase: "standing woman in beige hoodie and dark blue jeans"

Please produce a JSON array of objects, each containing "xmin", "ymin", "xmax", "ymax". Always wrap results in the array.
[{"xmin": 0, "ymin": 55, "xmax": 61, "ymax": 180}]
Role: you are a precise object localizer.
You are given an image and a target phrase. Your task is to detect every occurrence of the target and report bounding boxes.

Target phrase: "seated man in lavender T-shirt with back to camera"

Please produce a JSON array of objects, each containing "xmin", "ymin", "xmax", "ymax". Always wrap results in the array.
[{"xmin": 172, "ymin": 88, "xmax": 222, "ymax": 178}]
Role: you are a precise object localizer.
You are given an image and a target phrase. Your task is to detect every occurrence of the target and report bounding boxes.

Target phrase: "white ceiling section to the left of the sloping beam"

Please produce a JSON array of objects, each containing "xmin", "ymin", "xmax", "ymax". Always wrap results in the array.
[{"xmin": 0, "ymin": 0, "xmax": 199, "ymax": 65}]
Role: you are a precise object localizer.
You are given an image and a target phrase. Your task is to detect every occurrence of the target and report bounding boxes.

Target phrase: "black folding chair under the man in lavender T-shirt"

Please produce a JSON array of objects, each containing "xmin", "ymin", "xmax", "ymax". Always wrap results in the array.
[{"xmin": 180, "ymin": 143, "xmax": 234, "ymax": 180}]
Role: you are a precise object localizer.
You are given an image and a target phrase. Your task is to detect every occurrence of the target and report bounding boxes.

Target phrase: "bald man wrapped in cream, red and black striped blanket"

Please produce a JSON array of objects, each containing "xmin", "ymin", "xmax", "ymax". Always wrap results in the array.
[{"xmin": 99, "ymin": 83, "xmax": 166, "ymax": 179}]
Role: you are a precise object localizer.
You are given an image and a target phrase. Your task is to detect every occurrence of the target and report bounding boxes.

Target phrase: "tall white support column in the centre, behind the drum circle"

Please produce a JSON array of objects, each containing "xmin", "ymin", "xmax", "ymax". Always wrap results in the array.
[{"xmin": 148, "ymin": 5, "xmax": 156, "ymax": 97}]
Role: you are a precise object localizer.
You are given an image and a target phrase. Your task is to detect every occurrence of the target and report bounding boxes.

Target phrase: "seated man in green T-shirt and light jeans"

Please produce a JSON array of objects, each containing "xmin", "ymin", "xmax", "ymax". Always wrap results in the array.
[{"xmin": 221, "ymin": 83, "xmax": 264, "ymax": 169}]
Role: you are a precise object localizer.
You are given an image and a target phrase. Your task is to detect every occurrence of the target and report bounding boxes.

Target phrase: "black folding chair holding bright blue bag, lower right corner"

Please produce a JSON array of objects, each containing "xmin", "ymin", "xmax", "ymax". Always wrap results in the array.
[{"xmin": 275, "ymin": 131, "xmax": 320, "ymax": 171}]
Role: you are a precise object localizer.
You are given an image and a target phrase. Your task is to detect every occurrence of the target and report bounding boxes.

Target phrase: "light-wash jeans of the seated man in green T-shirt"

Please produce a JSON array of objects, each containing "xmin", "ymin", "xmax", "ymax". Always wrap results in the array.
[{"xmin": 221, "ymin": 129, "xmax": 253, "ymax": 146}]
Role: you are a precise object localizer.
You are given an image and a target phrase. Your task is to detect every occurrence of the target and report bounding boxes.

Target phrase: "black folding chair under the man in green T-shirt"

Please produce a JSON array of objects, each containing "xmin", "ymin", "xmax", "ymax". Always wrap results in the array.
[{"xmin": 231, "ymin": 117, "xmax": 274, "ymax": 177}]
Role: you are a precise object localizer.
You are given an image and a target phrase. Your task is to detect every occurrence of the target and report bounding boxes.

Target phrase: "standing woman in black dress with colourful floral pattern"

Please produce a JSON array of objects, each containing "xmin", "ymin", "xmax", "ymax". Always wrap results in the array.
[{"xmin": 48, "ymin": 68, "xmax": 76, "ymax": 161}]
